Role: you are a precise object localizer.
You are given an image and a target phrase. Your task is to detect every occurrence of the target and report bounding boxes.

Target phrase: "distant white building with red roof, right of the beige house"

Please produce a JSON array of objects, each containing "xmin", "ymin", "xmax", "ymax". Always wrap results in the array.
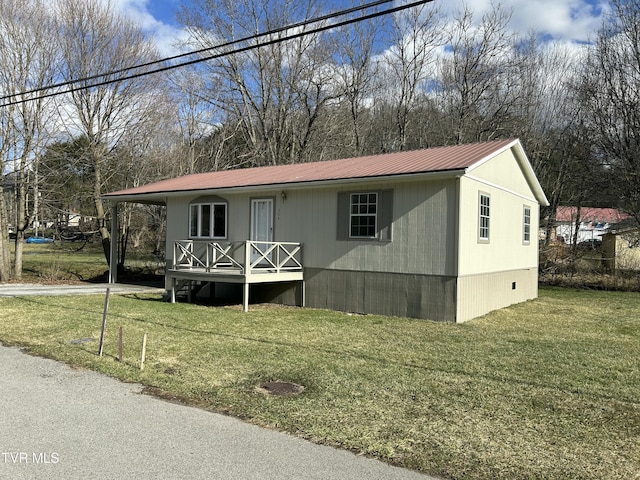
[{"xmin": 556, "ymin": 207, "xmax": 629, "ymax": 244}]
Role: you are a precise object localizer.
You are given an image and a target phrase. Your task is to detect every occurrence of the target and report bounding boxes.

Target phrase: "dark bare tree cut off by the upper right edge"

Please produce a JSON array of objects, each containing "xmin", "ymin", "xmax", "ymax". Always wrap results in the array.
[{"xmin": 578, "ymin": 0, "xmax": 640, "ymax": 222}]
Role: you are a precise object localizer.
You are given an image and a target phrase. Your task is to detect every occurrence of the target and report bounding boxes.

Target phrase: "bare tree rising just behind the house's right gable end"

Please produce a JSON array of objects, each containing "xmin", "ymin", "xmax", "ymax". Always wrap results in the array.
[{"xmin": 507, "ymin": 37, "xmax": 589, "ymax": 241}]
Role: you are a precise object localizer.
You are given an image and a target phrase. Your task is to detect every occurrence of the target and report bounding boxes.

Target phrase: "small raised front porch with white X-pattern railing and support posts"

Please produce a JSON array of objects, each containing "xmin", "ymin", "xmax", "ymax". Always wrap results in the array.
[{"xmin": 166, "ymin": 240, "xmax": 305, "ymax": 312}]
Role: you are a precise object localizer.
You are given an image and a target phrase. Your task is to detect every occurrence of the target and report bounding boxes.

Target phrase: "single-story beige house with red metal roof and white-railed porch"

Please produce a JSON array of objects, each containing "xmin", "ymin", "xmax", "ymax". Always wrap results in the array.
[{"xmin": 105, "ymin": 140, "xmax": 548, "ymax": 322}]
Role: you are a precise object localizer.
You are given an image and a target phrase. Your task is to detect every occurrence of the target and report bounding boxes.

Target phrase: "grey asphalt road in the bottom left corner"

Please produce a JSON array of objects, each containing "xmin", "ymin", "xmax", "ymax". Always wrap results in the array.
[{"xmin": 0, "ymin": 345, "xmax": 430, "ymax": 480}]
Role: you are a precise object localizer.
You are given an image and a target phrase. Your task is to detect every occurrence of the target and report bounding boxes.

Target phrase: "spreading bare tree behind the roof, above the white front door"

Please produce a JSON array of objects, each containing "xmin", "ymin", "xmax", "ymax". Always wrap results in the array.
[{"xmin": 181, "ymin": 0, "xmax": 333, "ymax": 164}]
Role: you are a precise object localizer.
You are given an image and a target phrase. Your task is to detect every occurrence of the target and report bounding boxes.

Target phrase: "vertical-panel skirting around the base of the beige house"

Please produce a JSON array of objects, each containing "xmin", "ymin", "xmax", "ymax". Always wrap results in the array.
[{"xmin": 194, "ymin": 268, "xmax": 538, "ymax": 322}]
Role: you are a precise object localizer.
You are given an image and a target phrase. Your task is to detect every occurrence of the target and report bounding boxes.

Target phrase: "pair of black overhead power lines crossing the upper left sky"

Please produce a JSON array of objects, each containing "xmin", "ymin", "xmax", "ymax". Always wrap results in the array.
[{"xmin": 0, "ymin": 0, "xmax": 434, "ymax": 107}]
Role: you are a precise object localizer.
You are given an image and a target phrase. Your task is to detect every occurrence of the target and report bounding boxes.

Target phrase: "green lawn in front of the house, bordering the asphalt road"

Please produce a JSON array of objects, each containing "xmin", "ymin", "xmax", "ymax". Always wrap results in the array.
[{"xmin": 0, "ymin": 288, "xmax": 640, "ymax": 480}]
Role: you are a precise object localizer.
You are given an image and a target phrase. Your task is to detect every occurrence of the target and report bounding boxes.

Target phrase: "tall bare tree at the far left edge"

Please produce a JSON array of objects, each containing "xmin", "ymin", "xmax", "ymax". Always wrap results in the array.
[{"xmin": 0, "ymin": 0, "xmax": 56, "ymax": 279}]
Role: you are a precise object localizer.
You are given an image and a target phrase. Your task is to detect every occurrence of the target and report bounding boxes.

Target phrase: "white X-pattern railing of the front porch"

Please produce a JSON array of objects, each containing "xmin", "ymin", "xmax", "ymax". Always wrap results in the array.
[{"xmin": 172, "ymin": 240, "xmax": 302, "ymax": 275}]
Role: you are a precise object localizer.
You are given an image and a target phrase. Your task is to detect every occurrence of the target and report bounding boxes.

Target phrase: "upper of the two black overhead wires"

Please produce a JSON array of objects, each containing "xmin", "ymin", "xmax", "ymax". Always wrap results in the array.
[{"xmin": 0, "ymin": 0, "xmax": 394, "ymax": 105}]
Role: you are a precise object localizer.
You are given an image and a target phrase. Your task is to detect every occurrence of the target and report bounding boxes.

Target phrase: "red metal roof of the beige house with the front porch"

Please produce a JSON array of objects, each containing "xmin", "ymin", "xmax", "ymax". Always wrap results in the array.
[{"xmin": 105, "ymin": 140, "xmax": 514, "ymax": 198}]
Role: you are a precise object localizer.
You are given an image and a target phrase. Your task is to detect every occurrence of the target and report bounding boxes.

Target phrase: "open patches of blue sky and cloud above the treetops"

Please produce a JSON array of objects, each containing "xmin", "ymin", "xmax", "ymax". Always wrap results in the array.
[{"xmin": 113, "ymin": 0, "xmax": 608, "ymax": 55}]
